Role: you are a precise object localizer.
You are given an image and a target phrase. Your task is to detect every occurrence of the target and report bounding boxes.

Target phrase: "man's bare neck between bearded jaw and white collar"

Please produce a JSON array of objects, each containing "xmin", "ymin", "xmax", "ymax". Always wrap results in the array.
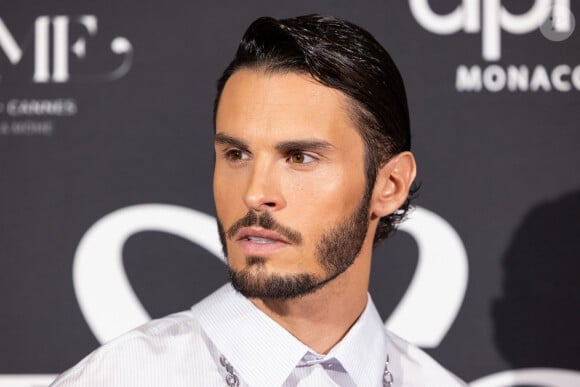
[{"xmin": 251, "ymin": 251, "xmax": 370, "ymax": 354}]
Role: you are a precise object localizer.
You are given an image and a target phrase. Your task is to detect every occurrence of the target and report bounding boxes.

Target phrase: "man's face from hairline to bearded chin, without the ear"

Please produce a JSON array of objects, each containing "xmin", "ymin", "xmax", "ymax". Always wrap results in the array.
[{"xmin": 214, "ymin": 69, "xmax": 369, "ymax": 298}]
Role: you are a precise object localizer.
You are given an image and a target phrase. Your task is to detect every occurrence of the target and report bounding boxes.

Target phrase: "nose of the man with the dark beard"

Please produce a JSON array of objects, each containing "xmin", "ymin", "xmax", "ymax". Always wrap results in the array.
[{"xmin": 244, "ymin": 162, "xmax": 286, "ymax": 212}]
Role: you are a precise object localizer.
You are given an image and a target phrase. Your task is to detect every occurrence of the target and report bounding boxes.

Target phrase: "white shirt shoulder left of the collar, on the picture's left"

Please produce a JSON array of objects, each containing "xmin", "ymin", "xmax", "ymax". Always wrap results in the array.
[{"xmin": 51, "ymin": 311, "xmax": 215, "ymax": 387}]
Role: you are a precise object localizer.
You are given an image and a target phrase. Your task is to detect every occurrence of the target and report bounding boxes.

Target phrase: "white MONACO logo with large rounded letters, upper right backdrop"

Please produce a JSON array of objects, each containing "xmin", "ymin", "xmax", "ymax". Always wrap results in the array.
[{"xmin": 409, "ymin": 0, "xmax": 580, "ymax": 92}]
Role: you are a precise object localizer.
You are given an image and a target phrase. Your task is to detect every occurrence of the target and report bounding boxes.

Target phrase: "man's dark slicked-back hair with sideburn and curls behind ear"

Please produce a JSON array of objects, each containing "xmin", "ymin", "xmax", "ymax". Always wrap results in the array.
[{"xmin": 214, "ymin": 15, "xmax": 411, "ymax": 244}]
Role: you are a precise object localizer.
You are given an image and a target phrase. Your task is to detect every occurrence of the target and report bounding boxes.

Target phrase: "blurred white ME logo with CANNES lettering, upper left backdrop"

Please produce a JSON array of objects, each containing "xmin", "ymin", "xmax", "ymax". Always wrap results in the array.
[{"xmin": 0, "ymin": 15, "xmax": 133, "ymax": 136}]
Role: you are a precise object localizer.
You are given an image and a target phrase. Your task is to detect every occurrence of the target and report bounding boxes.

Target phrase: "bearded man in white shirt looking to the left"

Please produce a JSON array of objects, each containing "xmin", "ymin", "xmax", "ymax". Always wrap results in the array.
[{"xmin": 53, "ymin": 15, "xmax": 464, "ymax": 387}]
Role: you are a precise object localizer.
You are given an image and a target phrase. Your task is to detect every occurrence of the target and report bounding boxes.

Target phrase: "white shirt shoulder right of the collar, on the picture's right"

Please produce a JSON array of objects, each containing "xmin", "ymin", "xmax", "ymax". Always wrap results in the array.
[{"xmin": 387, "ymin": 331, "xmax": 467, "ymax": 387}]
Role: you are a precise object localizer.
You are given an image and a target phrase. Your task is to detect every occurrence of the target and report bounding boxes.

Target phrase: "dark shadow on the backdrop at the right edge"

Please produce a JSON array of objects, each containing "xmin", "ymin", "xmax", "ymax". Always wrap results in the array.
[{"xmin": 492, "ymin": 191, "xmax": 580, "ymax": 369}]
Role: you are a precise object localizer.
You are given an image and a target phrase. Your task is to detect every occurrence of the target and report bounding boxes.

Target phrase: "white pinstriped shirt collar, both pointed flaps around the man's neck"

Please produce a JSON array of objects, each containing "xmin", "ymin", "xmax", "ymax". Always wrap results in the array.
[{"xmin": 192, "ymin": 284, "xmax": 386, "ymax": 386}]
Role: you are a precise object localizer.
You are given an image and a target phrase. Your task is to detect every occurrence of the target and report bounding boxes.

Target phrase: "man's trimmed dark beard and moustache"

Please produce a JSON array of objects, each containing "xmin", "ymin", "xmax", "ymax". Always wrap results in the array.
[{"xmin": 218, "ymin": 192, "xmax": 370, "ymax": 299}]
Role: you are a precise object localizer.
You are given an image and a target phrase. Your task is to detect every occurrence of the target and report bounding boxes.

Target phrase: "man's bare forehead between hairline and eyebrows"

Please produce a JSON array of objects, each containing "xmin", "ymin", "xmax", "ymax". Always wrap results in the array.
[{"xmin": 216, "ymin": 69, "xmax": 358, "ymax": 143}]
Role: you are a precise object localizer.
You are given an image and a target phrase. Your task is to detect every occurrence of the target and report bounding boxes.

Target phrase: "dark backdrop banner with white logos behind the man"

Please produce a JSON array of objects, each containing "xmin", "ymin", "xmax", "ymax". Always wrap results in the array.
[{"xmin": 0, "ymin": 0, "xmax": 580, "ymax": 387}]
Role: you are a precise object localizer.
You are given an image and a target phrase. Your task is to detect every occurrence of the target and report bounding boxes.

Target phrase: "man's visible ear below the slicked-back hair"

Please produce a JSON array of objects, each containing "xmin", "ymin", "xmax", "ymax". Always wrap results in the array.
[{"xmin": 371, "ymin": 152, "xmax": 417, "ymax": 218}]
